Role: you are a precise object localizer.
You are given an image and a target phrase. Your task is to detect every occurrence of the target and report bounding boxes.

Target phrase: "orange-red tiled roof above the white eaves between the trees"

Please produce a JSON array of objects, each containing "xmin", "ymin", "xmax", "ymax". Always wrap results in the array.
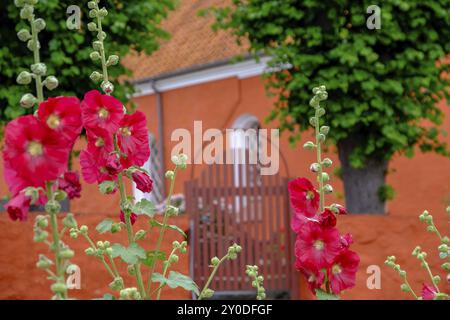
[{"xmin": 123, "ymin": 0, "xmax": 246, "ymax": 80}]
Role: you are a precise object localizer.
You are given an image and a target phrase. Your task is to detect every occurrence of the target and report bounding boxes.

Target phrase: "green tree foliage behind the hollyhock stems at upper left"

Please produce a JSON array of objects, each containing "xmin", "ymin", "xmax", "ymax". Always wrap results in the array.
[{"xmin": 0, "ymin": 0, "xmax": 175, "ymax": 130}]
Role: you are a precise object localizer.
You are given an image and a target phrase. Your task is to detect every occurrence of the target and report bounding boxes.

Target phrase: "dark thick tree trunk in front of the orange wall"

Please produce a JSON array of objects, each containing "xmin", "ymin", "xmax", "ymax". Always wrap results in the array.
[{"xmin": 338, "ymin": 137, "xmax": 389, "ymax": 214}]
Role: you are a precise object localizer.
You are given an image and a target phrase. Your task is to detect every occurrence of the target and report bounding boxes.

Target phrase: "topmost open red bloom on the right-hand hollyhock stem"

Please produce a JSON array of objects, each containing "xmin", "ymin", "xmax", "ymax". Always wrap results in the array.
[{"xmin": 288, "ymin": 178, "xmax": 320, "ymax": 218}]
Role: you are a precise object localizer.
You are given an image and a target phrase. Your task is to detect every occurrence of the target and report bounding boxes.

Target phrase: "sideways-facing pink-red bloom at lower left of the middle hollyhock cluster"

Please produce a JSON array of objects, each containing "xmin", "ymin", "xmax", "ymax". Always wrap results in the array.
[{"xmin": 80, "ymin": 145, "xmax": 115, "ymax": 183}]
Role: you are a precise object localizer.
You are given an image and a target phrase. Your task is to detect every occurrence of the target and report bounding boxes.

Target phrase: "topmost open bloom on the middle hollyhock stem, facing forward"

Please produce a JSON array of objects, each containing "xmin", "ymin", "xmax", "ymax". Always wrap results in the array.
[{"xmin": 81, "ymin": 90, "xmax": 124, "ymax": 134}]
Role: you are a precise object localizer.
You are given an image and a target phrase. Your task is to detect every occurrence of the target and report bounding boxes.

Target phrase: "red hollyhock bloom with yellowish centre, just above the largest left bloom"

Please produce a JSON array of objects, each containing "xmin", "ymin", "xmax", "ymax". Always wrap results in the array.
[{"xmin": 38, "ymin": 97, "xmax": 82, "ymax": 144}]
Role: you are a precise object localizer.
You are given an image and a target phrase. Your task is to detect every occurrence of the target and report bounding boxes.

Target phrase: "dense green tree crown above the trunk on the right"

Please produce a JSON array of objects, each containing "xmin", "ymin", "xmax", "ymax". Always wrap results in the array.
[{"xmin": 207, "ymin": 0, "xmax": 450, "ymax": 163}]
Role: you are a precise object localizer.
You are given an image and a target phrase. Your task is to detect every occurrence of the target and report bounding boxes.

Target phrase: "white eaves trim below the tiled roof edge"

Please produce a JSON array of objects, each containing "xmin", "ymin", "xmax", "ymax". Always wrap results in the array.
[{"xmin": 133, "ymin": 57, "xmax": 271, "ymax": 97}]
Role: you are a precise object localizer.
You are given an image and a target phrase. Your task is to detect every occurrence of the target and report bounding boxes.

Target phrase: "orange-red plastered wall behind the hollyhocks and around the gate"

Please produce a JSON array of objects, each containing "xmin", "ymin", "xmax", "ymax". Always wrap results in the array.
[{"xmin": 0, "ymin": 77, "xmax": 450, "ymax": 299}]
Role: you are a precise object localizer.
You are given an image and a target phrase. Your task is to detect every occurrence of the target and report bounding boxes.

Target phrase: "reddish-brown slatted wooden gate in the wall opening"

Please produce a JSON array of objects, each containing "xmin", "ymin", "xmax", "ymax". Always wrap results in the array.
[{"xmin": 185, "ymin": 157, "xmax": 299, "ymax": 299}]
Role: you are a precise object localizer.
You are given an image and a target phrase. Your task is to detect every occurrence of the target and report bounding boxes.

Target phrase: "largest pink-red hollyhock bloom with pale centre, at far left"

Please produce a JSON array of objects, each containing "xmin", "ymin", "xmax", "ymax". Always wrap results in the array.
[{"xmin": 3, "ymin": 115, "xmax": 69, "ymax": 189}]
